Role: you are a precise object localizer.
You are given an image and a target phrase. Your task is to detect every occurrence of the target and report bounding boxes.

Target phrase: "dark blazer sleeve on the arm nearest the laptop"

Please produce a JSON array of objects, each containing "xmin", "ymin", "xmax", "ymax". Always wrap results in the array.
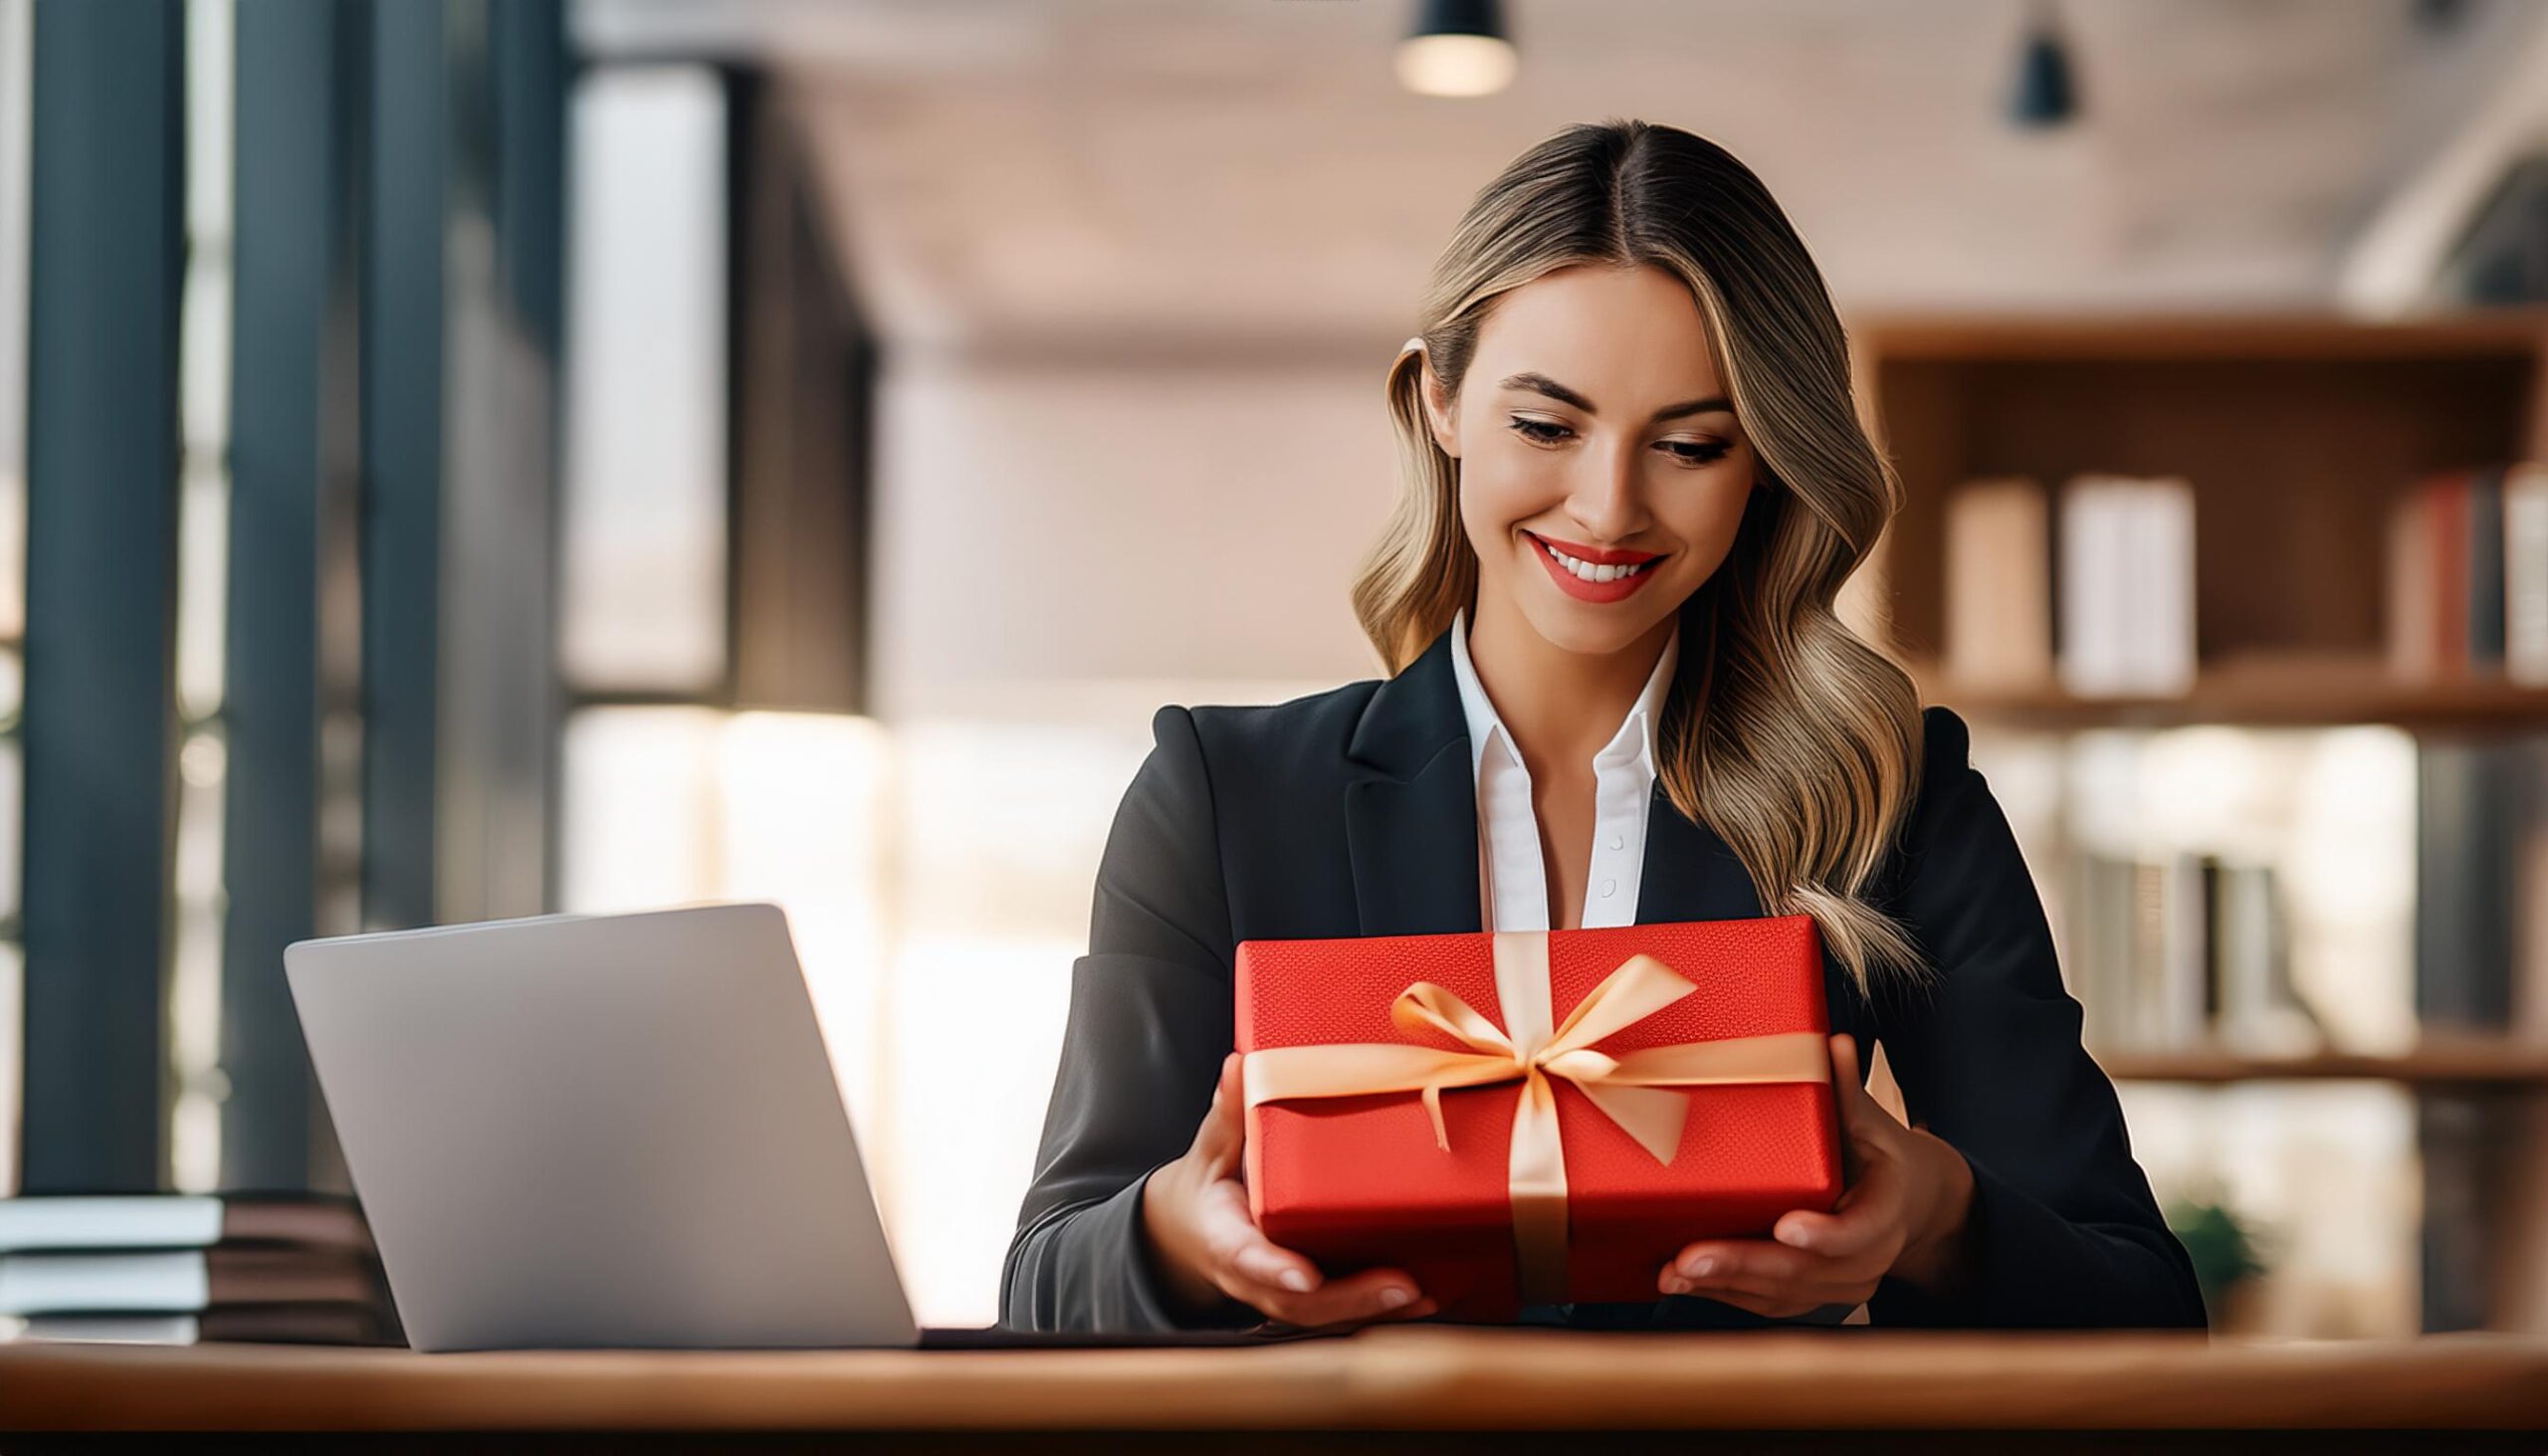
[{"xmin": 999, "ymin": 707, "xmax": 1264, "ymax": 1331}]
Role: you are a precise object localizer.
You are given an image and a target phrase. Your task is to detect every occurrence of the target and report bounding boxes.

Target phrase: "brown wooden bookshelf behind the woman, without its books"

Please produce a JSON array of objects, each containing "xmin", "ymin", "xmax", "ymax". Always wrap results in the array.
[{"xmin": 1844, "ymin": 306, "xmax": 2548, "ymax": 1331}]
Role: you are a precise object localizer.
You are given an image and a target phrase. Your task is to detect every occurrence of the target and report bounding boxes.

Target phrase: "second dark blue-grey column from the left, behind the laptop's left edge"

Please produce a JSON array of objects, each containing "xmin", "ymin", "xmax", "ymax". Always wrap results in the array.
[{"xmin": 222, "ymin": 0, "xmax": 359, "ymax": 1188}]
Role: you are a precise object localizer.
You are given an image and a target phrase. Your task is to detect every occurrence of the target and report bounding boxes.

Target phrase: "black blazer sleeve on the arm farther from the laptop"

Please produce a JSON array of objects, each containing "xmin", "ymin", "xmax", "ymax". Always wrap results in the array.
[{"xmin": 1867, "ymin": 707, "xmax": 2207, "ymax": 1329}]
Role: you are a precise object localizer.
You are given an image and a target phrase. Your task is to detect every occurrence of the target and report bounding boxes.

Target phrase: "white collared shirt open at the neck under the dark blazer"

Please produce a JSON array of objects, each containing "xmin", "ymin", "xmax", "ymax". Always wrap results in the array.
[{"xmin": 1450, "ymin": 607, "xmax": 1682, "ymax": 931}]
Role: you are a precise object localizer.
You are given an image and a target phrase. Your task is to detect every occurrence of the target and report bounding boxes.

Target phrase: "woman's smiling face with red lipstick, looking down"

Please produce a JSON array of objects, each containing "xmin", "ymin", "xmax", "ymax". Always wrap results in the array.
[{"xmin": 1424, "ymin": 265, "xmax": 1756, "ymax": 655}]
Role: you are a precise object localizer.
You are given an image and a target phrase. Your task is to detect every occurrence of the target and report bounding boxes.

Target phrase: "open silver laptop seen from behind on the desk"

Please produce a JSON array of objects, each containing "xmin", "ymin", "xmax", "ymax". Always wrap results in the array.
[{"xmin": 283, "ymin": 906, "xmax": 923, "ymax": 1349}]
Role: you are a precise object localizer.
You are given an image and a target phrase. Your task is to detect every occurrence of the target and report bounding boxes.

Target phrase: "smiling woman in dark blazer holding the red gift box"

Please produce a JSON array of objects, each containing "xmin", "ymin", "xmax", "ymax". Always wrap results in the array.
[{"xmin": 1001, "ymin": 119, "xmax": 2207, "ymax": 1329}]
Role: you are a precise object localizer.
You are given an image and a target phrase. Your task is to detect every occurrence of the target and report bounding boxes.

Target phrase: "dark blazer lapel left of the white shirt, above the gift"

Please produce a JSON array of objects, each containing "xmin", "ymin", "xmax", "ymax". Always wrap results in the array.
[{"xmin": 1346, "ymin": 627, "xmax": 1485, "ymax": 936}]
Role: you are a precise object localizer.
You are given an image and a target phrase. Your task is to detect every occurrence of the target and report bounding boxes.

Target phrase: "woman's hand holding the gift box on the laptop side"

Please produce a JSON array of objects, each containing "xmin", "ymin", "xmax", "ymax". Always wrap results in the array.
[{"xmin": 1142, "ymin": 1053, "xmax": 1437, "ymax": 1329}]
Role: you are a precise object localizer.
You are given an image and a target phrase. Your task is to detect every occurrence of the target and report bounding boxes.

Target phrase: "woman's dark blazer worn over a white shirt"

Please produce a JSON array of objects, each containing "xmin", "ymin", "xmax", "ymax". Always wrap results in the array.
[{"xmin": 999, "ymin": 630, "xmax": 2207, "ymax": 1331}]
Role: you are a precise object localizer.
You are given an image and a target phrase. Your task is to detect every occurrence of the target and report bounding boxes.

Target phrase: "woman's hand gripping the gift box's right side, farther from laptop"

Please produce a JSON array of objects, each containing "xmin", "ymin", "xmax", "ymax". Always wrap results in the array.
[{"xmin": 1656, "ymin": 1033, "xmax": 1972, "ymax": 1319}]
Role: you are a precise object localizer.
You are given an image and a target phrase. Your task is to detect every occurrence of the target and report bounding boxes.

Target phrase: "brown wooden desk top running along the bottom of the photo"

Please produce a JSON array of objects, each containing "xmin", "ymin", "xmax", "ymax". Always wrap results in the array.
[{"xmin": 0, "ymin": 1326, "xmax": 2548, "ymax": 1453}]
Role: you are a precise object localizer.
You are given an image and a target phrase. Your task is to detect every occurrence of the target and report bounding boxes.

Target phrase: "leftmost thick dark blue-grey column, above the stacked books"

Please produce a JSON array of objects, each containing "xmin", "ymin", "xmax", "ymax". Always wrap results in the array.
[{"xmin": 23, "ymin": 0, "xmax": 186, "ymax": 1191}]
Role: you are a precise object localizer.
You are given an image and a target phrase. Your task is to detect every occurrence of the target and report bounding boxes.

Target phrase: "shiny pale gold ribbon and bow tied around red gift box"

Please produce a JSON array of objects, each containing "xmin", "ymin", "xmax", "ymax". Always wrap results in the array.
[{"xmin": 1241, "ymin": 931, "xmax": 1832, "ymax": 1306}]
